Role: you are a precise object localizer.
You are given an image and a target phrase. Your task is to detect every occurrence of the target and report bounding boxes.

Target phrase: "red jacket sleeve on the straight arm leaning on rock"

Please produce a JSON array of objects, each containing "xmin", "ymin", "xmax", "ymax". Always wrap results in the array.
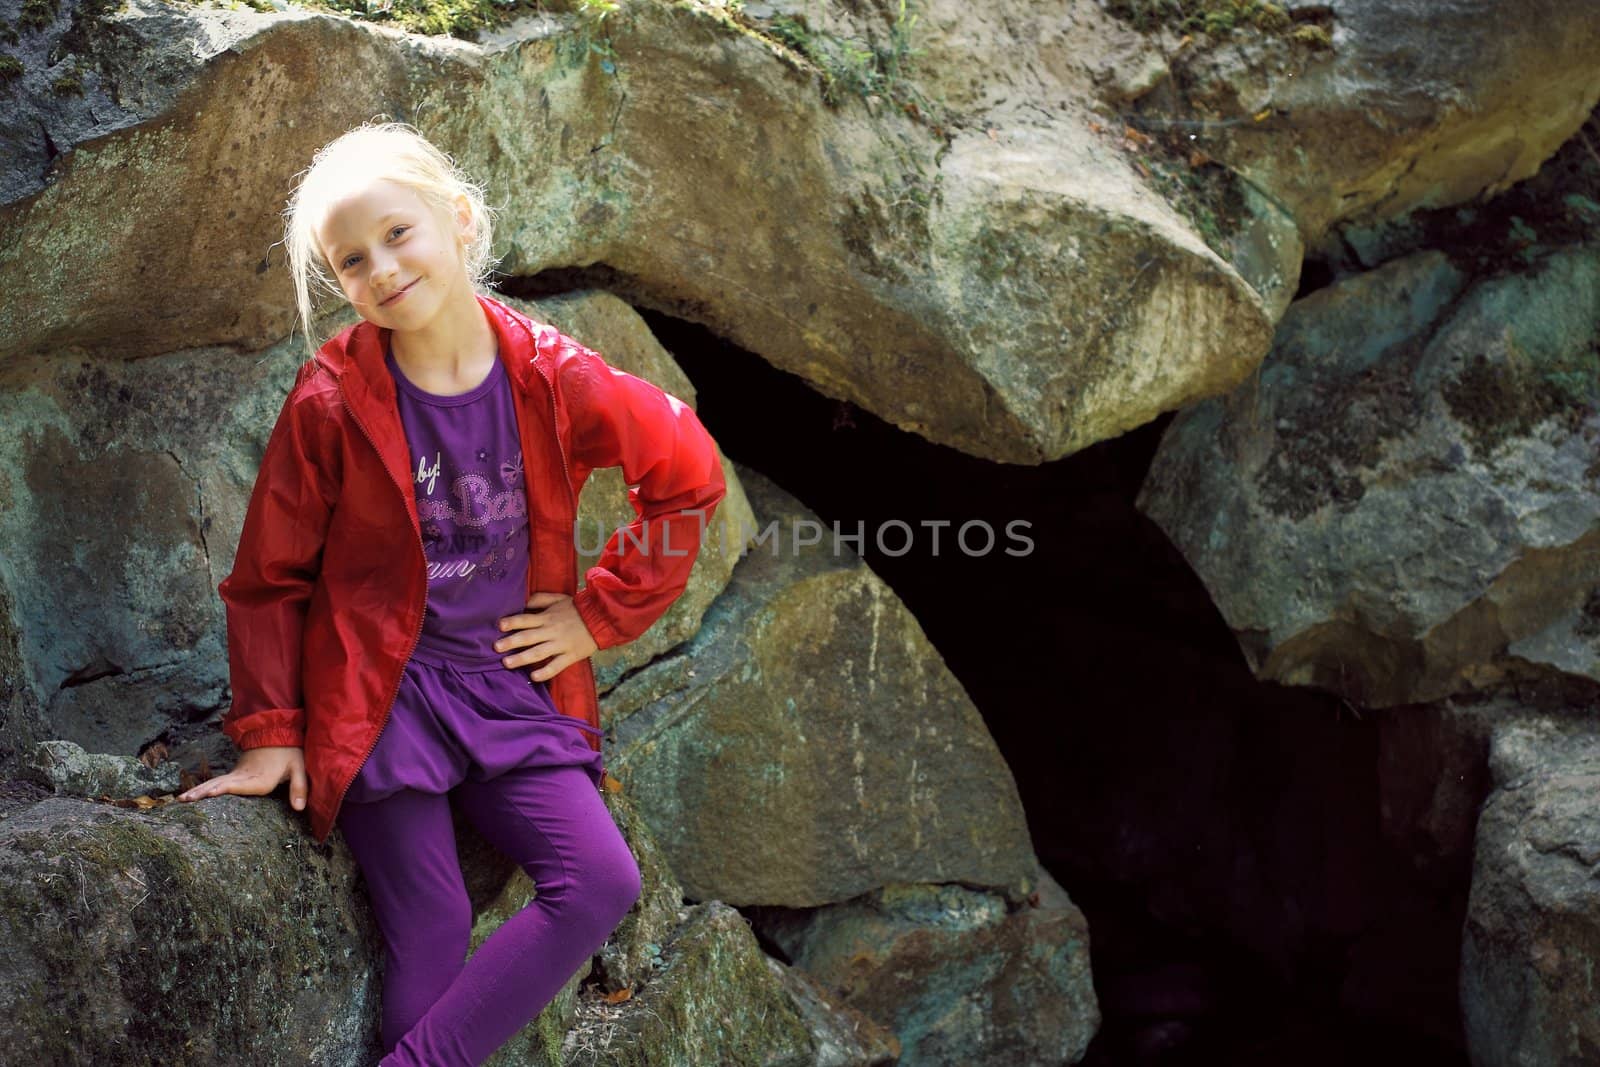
[{"xmin": 218, "ymin": 362, "xmax": 338, "ymax": 750}]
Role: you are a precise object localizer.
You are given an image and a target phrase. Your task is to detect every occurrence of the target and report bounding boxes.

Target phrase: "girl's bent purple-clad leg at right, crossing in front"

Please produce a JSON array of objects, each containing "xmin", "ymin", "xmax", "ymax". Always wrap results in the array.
[{"xmin": 381, "ymin": 766, "xmax": 640, "ymax": 1067}]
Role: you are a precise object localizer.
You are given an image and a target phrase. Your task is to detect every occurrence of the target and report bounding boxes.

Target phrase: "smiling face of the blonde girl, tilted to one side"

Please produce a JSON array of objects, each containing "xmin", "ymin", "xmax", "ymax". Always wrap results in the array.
[{"xmin": 317, "ymin": 178, "xmax": 472, "ymax": 331}]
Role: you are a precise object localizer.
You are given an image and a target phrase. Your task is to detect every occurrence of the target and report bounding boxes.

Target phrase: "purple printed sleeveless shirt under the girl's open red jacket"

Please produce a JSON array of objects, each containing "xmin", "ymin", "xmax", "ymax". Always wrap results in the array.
[{"xmin": 386, "ymin": 343, "xmax": 528, "ymax": 665}]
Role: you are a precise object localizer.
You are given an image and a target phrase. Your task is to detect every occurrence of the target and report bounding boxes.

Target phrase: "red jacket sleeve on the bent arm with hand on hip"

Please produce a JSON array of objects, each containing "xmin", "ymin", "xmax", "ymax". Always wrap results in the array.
[{"xmin": 562, "ymin": 336, "xmax": 726, "ymax": 648}]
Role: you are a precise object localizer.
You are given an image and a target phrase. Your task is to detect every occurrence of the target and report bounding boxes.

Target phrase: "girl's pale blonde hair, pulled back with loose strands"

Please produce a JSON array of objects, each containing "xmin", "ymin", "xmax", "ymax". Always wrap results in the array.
[{"xmin": 283, "ymin": 122, "xmax": 494, "ymax": 355}]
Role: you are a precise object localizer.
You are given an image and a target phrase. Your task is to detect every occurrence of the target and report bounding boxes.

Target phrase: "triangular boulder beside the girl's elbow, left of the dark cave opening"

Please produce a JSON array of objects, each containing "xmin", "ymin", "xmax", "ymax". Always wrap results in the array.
[{"xmin": 602, "ymin": 467, "xmax": 1035, "ymax": 907}]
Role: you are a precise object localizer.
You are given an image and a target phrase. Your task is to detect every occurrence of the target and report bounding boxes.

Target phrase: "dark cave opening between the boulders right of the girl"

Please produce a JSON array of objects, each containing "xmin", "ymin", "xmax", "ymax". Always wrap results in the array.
[{"xmin": 505, "ymin": 277, "xmax": 1469, "ymax": 1067}]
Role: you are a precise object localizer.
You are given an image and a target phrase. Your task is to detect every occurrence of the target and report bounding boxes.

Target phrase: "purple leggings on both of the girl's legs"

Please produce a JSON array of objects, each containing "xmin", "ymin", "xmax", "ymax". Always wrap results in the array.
[{"xmin": 339, "ymin": 765, "xmax": 640, "ymax": 1067}]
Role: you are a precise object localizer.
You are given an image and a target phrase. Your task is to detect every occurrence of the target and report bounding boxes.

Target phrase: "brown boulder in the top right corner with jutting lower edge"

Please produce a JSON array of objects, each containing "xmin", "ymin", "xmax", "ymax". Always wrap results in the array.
[{"xmin": 1101, "ymin": 0, "xmax": 1600, "ymax": 245}]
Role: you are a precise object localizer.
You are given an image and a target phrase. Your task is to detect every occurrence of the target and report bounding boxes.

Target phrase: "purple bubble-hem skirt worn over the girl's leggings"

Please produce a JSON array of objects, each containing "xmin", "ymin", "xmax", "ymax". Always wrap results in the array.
[{"xmin": 344, "ymin": 654, "xmax": 603, "ymax": 803}]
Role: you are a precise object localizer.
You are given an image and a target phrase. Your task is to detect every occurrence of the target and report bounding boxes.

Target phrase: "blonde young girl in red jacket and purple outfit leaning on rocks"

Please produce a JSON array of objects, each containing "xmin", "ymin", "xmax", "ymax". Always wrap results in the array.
[{"xmin": 181, "ymin": 123, "xmax": 723, "ymax": 1067}]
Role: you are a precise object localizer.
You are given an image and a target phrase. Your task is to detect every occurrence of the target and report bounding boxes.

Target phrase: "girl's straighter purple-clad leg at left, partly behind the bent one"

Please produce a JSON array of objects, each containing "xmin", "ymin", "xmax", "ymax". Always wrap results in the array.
[{"xmin": 339, "ymin": 789, "xmax": 472, "ymax": 1053}]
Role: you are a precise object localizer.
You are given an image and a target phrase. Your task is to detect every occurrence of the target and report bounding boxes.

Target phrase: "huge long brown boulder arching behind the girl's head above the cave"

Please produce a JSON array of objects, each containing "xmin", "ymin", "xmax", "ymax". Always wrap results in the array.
[{"xmin": 0, "ymin": 0, "xmax": 1273, "ymax": 462}]
